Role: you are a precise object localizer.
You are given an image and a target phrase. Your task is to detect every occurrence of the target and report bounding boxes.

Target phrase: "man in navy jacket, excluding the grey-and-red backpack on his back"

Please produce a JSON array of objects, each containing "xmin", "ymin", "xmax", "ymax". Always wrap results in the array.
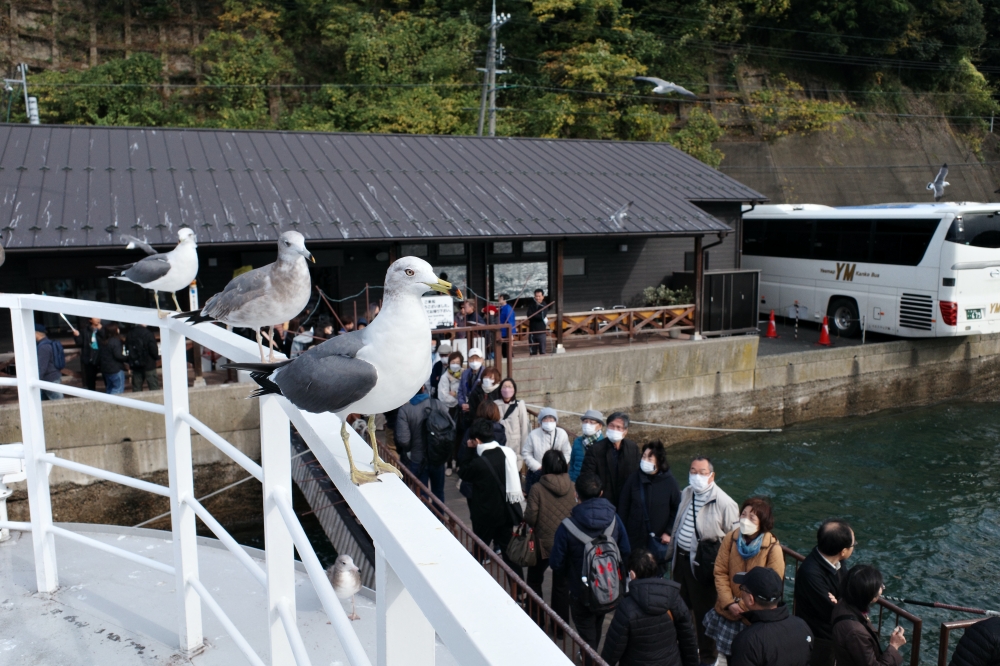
[{"xmin": 549, "ymin": 472, "xmax": 631, "ymax": 650}]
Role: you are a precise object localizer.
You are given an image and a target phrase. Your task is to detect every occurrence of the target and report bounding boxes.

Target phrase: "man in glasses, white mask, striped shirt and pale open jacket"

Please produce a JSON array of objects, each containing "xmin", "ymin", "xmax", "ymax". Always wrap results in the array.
[{"xmin": 667, "ymin": 456, "xmax": 740, "ymax": 664}]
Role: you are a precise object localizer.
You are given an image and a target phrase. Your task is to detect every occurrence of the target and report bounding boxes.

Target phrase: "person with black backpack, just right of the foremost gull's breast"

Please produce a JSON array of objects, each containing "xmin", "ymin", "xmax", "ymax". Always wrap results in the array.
[{"xmin": 395, "ymin": 387, "xmax": 455, "ymax": 502}]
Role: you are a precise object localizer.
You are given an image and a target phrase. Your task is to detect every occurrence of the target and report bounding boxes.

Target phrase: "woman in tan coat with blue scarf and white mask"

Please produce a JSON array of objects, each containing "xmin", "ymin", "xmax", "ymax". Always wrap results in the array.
[{"xmin": 705, "ymin": 497, "xmax": 785, "ymax": 657}]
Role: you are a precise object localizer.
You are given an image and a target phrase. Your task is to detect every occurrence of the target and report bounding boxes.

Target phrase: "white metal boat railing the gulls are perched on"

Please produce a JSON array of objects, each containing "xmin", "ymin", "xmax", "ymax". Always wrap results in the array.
[{"xmin": 0, "ymin": 294, "xmax": 568, "ymax": 666}]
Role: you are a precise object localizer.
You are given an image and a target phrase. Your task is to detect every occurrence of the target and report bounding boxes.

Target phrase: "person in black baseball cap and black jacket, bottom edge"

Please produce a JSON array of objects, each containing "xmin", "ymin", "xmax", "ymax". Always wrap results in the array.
[{"xmin": 728, "ymin": 567, "xmax": 813, "ymax": 666}]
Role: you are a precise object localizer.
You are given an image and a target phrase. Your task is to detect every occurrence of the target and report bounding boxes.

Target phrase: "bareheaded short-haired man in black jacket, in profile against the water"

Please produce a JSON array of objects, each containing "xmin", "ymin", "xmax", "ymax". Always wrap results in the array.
[{"xmin": 795, "ymin": 519, "xmax": 854, "ymax": 666}]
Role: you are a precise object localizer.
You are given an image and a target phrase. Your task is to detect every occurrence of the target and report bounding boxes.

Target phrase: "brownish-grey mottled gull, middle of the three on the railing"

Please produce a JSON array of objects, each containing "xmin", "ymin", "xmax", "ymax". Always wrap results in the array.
[{"xmin": 174, "ymin": 231, "xmax": 316, "ymax": 363}]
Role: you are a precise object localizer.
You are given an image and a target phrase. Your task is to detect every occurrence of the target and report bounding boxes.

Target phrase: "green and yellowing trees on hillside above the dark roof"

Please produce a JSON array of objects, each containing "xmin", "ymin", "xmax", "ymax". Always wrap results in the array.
[{"xmin": 5, "ymin": 0, "xmax": 1000, "ymax": 165}]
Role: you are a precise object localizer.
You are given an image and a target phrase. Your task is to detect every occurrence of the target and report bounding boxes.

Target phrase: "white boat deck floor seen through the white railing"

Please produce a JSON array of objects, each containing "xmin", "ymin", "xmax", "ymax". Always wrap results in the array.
[{"xmin": 0, "ymin": 524, "xmax": 457, "ymax": 666}]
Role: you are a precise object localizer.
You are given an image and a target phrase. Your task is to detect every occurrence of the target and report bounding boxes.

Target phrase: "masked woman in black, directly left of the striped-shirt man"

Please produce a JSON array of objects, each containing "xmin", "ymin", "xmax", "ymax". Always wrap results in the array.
[{"xmin": 618, "ymin": 441, "xmax": 681, "ymax": 574}]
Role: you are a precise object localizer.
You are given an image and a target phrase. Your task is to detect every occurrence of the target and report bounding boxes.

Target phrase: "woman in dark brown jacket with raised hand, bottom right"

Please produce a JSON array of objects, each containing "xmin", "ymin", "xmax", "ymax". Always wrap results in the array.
[{"xmin": 833, "ymin": 564, "xmax": 906, "ymax": 666}]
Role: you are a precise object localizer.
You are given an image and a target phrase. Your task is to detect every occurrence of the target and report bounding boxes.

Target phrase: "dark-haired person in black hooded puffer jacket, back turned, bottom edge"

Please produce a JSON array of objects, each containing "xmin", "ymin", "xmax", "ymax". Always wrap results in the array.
[{"xmin": 601, "ymin": 548, "xmax": 698, "ymax": 666}]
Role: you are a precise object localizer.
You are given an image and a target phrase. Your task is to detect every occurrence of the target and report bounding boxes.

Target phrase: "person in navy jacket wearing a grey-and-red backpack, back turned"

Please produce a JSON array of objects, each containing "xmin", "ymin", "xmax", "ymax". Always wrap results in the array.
[{"xmin": 549, "ymin": 474, "xmax": 632, "ymax": 663}]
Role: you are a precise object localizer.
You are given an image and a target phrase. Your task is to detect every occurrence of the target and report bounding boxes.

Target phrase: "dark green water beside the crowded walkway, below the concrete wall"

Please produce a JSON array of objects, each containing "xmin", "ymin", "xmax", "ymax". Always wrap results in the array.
[{"xmin": 669, "ymin": 403, "xmax": 1000, "ymax": 664}]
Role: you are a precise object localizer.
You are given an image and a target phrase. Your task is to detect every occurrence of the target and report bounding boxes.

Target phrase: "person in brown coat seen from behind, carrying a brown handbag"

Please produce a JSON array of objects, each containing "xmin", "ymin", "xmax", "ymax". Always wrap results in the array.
[{"xmin": 524, "ymin": 449, "xmax": 576, "ymax": 628}]
